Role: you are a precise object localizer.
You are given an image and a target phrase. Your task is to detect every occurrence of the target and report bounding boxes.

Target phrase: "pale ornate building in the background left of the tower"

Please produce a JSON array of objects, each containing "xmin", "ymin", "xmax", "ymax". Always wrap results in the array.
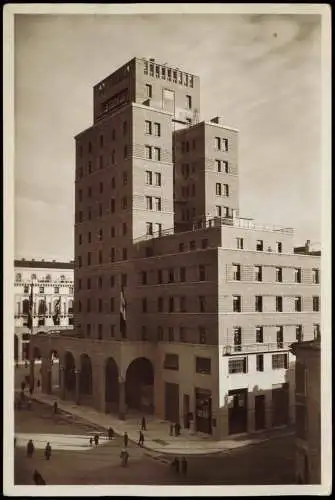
[{"xmin": 14, "ymin": 259, "xmax": 74, "ymax": 361}]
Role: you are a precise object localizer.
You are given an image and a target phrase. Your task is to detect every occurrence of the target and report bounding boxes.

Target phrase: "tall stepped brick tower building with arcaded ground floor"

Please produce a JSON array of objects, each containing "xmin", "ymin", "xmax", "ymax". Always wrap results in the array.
[{"xmin": 30, "ymin": 58, "xmax": 320, "ymax": 439}]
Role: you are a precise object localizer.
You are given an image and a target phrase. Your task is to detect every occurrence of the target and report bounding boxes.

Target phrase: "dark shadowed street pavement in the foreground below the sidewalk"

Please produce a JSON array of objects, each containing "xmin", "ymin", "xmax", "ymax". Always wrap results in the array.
[{"xmin": 15, "ymin": 401, "xmax": 294, "ymax": 485}]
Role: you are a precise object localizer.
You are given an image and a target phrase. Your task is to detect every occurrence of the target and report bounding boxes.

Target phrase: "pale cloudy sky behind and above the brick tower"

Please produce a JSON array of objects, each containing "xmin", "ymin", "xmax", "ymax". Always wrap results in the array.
[{"xmin": 14, "ymin": 14, "xmax": 321, "ymax": 260}]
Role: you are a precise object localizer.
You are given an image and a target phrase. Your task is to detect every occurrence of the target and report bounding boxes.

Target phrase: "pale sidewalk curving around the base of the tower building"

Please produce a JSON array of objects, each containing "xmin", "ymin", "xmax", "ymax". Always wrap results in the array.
[{"xmin": 28, "ymin": 393, "xmax": 290, "ymax": 455}]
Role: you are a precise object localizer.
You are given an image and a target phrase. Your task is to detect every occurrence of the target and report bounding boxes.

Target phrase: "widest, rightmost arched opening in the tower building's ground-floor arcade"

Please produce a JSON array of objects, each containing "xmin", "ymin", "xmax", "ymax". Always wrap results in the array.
[{"xmin": 126, "ymin": 358, "xmax": 154, "ymax": 413}]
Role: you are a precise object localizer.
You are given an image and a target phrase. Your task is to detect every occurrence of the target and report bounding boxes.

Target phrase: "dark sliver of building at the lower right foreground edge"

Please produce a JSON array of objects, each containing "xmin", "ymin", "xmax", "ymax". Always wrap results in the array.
[{"xmin": 292, "ymin": 335, "xmax": 321, "ymax": 484}]
